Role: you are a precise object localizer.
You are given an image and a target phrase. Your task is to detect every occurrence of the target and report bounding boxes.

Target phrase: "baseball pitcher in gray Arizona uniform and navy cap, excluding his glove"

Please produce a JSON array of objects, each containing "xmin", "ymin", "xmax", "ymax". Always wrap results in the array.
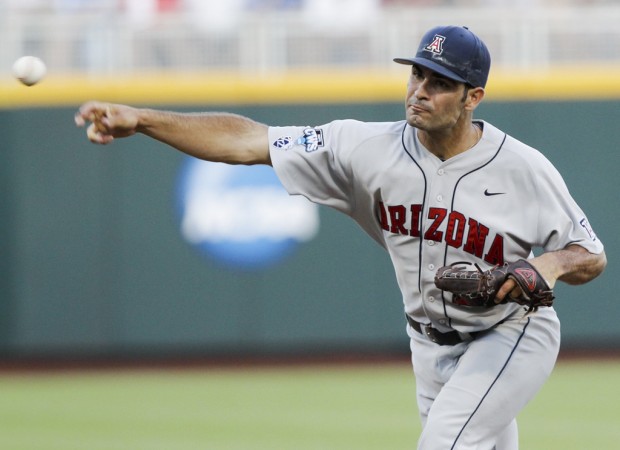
[{"xmin": 76, "ymin": 26, "xmax": 606, "ymax": 450}]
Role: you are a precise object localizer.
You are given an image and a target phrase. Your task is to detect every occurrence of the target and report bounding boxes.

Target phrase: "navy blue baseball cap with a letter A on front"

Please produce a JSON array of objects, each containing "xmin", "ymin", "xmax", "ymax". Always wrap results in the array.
[{"xmin": 394, "ymin": 26, "xmax": 491, "ymax": 87}]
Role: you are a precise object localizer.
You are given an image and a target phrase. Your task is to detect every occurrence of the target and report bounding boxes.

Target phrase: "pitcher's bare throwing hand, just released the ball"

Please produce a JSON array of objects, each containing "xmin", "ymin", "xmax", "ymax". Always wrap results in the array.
[{"xmin": 75, "ymin": 101, "xmax": 138, "ymax": 144}]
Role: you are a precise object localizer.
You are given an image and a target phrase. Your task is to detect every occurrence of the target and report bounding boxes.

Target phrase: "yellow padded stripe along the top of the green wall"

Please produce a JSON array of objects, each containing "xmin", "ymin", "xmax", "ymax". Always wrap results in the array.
[{"xmin": 0, "ymin": 67, "xmax": 620, "ymax": 109}]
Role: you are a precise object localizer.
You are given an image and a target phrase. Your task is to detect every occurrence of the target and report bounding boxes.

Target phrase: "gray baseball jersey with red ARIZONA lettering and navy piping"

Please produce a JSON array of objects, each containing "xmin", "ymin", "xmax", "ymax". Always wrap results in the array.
[{"xmin": 269, "ymin": 120, "xmax": 603, "ymax": 332}]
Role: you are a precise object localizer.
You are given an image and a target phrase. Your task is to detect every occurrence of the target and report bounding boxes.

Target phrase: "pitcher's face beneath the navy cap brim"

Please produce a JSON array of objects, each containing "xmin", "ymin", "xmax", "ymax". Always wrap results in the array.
[{"xmin": 406, "ymin": 65, "xmax": 467, "ymax": 132}]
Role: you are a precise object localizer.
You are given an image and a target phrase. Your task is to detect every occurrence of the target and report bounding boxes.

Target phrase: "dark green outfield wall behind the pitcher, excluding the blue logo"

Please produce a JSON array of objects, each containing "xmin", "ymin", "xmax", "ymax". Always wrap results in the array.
[{"xmin": 0, "ymin": 77, "xmax": 620, "ymax": 357}]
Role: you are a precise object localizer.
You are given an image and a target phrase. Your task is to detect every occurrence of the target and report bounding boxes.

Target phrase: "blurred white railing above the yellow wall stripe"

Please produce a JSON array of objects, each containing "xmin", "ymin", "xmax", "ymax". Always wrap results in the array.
[{"xmin": 0, "ymin": 5, "xmax": 620, "ymax": 76}]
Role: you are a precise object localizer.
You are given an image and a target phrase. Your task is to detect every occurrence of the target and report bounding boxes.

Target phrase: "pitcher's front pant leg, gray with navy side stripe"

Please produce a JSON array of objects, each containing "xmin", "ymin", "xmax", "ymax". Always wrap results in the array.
[{"xmin": 419, "ymin": 308, "xmax": 559, "ymax": 450}]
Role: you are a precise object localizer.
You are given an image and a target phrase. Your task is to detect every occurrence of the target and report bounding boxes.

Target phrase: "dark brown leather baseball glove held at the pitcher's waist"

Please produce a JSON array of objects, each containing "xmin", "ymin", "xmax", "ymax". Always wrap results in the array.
[{"xmin": 435, "ymin": 259, "xmax": 554, "ymax": 312}]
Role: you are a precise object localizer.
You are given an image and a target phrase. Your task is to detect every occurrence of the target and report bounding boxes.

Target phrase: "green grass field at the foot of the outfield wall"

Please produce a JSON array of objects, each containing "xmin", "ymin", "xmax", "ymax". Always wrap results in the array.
[{"xmin": 0, "ymin": 361, "xmax": 620, "ymax": 450}]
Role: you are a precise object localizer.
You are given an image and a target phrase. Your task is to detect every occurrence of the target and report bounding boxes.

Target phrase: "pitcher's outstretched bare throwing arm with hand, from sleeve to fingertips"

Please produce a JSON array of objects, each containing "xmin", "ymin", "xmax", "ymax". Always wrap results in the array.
[{"xmin": 75, "ymin": 102, "xmax": 271, "ymax": 164}]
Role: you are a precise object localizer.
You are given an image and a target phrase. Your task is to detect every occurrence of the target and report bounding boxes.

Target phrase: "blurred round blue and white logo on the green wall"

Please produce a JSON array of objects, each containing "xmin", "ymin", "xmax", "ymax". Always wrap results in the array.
[{"xmin": 177, "ymin": 157, "xmax": 319, "ymax": 270}]
